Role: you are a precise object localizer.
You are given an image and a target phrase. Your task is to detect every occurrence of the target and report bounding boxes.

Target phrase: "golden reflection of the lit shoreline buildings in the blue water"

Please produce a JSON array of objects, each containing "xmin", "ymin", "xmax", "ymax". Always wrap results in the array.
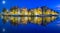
[{"xmin": 2, "ymin": 16, "xmax": 56, "ymax": 24}]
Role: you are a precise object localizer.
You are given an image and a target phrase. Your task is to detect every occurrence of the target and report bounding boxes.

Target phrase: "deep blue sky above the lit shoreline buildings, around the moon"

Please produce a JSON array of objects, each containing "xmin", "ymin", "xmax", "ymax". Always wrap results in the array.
[{"xmin": 0, "ymin": 0, "xmax": 60, "ymax": 9}]
